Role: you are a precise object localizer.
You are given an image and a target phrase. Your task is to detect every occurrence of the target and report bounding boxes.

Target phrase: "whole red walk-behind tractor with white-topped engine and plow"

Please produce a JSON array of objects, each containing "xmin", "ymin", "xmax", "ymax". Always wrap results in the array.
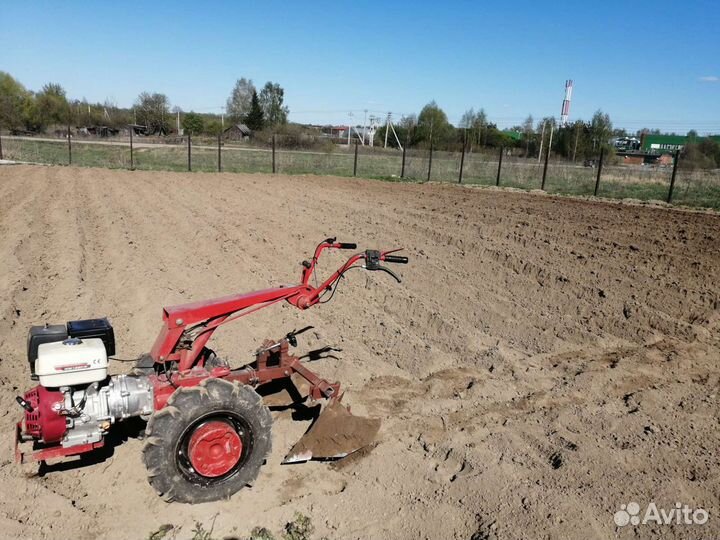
[{"xmin": 15, "ymin": 238, "xmax": 408, "ymax": 503}]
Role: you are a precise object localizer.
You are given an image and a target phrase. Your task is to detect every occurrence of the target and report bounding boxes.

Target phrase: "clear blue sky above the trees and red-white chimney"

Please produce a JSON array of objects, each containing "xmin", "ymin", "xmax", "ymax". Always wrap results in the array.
[{"xmin": 0, "ymin": 0, "xmax": 720, "ymax": 133}]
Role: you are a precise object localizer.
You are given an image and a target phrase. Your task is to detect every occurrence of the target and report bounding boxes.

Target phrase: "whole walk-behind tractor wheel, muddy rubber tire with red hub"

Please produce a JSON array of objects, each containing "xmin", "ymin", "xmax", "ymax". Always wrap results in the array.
[{"xmin": 143, "ymin": 378, "xmax": 272, "ymax": 503}]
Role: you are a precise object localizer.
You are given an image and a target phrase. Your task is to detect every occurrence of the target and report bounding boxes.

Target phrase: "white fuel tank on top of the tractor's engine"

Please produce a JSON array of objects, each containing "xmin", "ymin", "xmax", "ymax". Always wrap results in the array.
[{"xmin": 35, "ymin": 338, "xmax": 108, "ymax": 388}]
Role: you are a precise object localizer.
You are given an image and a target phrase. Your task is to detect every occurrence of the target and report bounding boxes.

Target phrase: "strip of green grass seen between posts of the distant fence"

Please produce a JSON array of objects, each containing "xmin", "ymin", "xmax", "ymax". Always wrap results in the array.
[{"xmin": 3, "ymin": 138, "xmax": 720, "ymax": 210}]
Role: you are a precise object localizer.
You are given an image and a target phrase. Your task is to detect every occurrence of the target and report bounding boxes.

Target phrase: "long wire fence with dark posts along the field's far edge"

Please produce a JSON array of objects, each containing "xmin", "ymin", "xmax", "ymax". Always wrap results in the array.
[{"xmin": 0, "ymin": 135, "xmax": 720, "ymax": 210}]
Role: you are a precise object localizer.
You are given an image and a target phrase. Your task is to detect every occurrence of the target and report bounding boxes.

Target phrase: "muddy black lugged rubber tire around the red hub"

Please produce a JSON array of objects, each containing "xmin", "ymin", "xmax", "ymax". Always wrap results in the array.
[{"xmin": 143, "ymin": 378, "xmax": 272, "ymax": 503}]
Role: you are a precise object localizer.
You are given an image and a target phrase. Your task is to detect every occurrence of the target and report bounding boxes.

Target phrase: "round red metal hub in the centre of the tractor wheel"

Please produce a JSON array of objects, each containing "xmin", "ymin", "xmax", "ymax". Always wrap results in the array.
[{"xmin": 188, "ymin": 420, "xmax": 242, "ymax": 478}]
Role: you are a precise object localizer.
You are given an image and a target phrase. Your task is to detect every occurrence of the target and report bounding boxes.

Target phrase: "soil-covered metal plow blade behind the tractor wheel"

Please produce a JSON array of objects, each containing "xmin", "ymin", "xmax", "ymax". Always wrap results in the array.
[{"xmin": 283, "ymin": 402, "xmax": 380, "ymax": 463}]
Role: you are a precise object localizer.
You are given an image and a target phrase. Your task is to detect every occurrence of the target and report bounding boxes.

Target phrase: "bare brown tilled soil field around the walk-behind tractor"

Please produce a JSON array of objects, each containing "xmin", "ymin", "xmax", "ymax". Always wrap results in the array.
[{"xmin": 0, "ymin": 166, "xmax": 720, "ymax": 539}]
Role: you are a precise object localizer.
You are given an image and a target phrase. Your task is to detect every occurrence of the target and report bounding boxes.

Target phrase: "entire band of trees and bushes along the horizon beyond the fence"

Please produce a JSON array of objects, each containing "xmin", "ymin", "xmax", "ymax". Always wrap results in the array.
[{"xmin": 0, "ymin": 71, "xmax": 720, "ymax": 168}]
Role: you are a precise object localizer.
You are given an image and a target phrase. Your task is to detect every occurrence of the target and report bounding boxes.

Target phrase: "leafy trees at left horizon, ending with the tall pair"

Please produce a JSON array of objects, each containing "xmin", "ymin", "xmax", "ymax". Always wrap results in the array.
[{"xmin": 0, "ymin": 71, "xmax": 289, "ymax": 135}]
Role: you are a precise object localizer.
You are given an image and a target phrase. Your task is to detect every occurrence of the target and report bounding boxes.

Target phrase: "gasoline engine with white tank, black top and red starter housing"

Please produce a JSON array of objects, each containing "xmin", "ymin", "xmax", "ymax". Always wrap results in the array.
[{"xmin": 17, "ymin": 319, "xmax": 153, "ymax": 449}]
